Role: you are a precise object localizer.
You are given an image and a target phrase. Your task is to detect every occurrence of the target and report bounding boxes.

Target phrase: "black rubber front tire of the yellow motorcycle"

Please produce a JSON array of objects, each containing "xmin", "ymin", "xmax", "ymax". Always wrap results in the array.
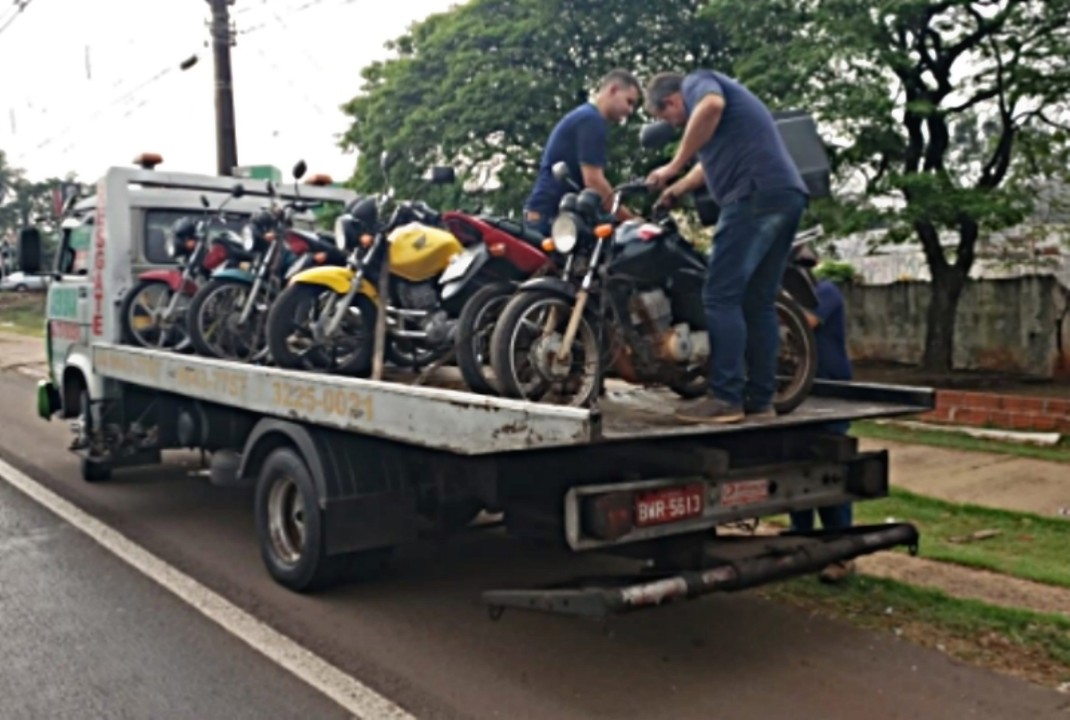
[{"xmin": 268, "ymin": 282, "xmax": 377, "ymax": 377}]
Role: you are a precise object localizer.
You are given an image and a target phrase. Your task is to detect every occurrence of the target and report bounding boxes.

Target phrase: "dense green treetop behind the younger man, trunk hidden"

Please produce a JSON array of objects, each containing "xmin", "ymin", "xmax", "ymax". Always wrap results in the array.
[{"xmin": 342, "ymin": 0, "xmax": 719, "ymax": 212}]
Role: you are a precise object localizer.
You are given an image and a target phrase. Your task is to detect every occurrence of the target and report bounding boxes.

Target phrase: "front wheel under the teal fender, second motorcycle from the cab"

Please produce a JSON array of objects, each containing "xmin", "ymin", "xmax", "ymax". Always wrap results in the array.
[{"xmin": 186, "ymin": 278, "xmax": 266, "ymax": 362}]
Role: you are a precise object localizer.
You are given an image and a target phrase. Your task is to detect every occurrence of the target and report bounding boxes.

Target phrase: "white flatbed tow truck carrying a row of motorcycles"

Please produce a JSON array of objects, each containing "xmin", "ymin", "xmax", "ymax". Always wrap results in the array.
[{"xmin": 12, "ymin": 158, "xmax": 934, "ymax": 618}]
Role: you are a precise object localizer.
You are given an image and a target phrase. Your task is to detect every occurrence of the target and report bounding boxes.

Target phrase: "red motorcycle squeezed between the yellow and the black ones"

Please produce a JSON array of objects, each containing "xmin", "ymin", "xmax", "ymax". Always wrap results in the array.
[{"xmin": 440, "ymin": 211, "xmax": 556, "ymax": 395}]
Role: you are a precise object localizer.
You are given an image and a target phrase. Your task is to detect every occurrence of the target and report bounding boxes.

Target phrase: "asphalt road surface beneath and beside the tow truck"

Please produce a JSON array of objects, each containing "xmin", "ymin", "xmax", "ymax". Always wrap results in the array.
[{"xmin": 0, "ymin": 373, "xmax": 1070, "ymax": 720}]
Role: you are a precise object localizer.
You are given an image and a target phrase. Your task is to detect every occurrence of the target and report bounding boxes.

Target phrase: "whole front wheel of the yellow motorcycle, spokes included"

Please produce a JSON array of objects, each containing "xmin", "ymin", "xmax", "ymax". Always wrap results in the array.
[{"xmin": 266, "ymin": 282, "xmax": 376, "ymax": 376}]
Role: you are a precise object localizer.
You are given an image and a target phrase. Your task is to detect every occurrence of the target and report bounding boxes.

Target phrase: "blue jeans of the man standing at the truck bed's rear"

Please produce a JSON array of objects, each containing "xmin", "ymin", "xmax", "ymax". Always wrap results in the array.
[{"xmin": 702, "ymin": 189, "xmax": 808, "ymax": 409}]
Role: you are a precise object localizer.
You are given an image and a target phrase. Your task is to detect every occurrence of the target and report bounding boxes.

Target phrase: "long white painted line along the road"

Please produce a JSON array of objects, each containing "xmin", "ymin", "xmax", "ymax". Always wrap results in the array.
[{"xmin": 0, "ymin": 460, "xmax": 415, "ymax": 720}]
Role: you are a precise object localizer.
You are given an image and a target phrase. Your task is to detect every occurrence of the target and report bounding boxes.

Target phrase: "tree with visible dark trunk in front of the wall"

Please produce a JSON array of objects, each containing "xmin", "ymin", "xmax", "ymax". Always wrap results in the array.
[{"xmin": 706, "ymin": 0, "xmax": 1070, "ymax": 371}]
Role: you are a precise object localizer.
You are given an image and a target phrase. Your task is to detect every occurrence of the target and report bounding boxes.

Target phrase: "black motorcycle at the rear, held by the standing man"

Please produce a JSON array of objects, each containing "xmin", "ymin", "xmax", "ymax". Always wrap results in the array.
[{"xmin": 490, "ymin": 164, "xmax": 817, "ymax": 413}]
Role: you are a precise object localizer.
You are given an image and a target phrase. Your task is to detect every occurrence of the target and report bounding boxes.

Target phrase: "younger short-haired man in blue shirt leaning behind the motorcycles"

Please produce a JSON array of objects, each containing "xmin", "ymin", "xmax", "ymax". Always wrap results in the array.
[{"xmin": 524, "ymin": 70, "xmax": 640, "ymax": 235}]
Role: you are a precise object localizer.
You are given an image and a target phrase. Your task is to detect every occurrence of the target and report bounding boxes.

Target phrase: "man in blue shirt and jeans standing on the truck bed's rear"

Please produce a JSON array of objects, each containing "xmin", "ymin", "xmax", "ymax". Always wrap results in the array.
[{"xmin": 646, "ymin": 70, "xmax": 809, "ymax": 423}]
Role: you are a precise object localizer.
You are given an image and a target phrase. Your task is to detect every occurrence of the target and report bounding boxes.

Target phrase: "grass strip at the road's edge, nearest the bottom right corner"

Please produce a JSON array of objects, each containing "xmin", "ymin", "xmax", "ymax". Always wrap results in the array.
[{"xmin": 760, "ymin": 576, "xmax": 1070, "ymax": 687}]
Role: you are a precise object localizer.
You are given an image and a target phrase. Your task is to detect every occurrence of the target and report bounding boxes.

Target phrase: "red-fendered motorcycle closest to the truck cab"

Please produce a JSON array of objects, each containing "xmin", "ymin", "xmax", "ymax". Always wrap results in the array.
[{"xmin": 121, "ymin": 196, "xmax": 253, "ymax": 351}]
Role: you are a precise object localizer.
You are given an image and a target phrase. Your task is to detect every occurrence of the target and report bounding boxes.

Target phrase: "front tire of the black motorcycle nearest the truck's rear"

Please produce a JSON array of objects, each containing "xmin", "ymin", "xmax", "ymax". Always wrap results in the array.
[{"xmin": 490, "ymin": 290, "xmax": 606, "ymax": 408}]
